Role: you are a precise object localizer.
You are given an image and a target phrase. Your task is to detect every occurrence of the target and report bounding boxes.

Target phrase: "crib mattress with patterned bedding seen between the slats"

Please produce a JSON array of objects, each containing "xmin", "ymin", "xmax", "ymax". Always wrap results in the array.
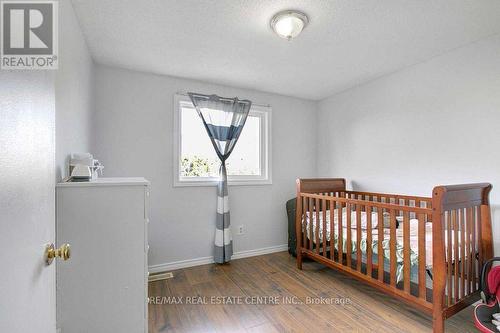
[{"xmin": 303, "ymin": 208, "xmax": 432, "ymax": 282}]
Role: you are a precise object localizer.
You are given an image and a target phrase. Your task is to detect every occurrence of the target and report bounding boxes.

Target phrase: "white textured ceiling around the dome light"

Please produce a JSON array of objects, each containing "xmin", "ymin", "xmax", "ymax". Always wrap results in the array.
[{"xmin": 69, "ymin": 0, "xmax": 500, "ymax": 100}]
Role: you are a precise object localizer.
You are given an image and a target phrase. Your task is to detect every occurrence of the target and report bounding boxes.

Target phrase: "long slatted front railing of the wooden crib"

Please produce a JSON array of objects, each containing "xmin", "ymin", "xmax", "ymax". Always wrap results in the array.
[{"xmin": 297, "ymin": 192, "xmax": 432, "ymax": 304}]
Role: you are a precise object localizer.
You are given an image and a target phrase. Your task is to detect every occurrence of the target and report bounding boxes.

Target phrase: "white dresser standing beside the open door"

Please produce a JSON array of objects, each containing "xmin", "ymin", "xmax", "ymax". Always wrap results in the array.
[{"xmin": 56, "ymin": 178, "xmax": 150, "ymax": 333}]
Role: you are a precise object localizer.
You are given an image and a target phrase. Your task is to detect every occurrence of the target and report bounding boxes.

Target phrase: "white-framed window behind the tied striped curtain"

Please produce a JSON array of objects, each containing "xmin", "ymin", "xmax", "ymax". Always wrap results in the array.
[{"xmin": 174, "ymin": 95, "xmax": 271, "ymax": 186}]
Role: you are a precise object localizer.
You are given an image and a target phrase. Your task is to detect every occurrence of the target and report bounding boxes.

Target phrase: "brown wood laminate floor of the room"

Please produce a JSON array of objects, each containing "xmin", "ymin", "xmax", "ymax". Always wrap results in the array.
[{"xmin": 149, "ymin": 252, "xmax": 476, "ymax": 333}]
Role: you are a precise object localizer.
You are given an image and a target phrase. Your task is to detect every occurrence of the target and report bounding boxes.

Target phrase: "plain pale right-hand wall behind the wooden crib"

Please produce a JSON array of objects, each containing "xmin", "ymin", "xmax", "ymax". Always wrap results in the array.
[{"xmin": 317, "ymin": 36, "xmax": 500, "ymax": 254}]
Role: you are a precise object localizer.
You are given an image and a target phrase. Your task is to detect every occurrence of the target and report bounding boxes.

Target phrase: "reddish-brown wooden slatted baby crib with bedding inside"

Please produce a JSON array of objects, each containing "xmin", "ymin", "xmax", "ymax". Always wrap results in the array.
[{"xmin": 296, "ymin": 178, "xmax": 493, "ymax": 332}]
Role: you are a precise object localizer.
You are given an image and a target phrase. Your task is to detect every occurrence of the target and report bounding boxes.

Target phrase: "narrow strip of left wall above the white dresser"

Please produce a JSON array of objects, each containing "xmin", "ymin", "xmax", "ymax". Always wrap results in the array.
[{"xmin": 55, "ymin": 0, "xmax": 94, "ymax": 180}]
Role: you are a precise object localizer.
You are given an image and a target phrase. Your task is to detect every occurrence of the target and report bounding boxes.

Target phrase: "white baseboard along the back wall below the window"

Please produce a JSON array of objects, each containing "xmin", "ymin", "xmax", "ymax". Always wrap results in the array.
[{"xmin": 149, "ymin": 244, "xmax": 288, "ymax": 274}]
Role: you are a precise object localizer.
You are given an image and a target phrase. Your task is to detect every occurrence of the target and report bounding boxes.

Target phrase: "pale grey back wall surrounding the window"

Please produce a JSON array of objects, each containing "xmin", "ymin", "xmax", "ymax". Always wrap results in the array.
[{"xmin": 91, "ymin": 66, "xmax": 316, "ymax": 265}]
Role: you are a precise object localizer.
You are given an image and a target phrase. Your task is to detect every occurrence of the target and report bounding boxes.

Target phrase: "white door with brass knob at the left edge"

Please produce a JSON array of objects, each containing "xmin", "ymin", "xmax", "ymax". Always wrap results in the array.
[{"xmin": 0, "ymin": 70, "xmax": 56, "ymax": 333}]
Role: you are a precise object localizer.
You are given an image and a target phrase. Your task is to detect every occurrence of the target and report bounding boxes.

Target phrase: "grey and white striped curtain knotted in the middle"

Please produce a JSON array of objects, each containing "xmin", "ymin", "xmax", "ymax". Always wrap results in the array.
[{"xmin": 188, "ymin": 93, "xmax": 252, "ymax": 263}]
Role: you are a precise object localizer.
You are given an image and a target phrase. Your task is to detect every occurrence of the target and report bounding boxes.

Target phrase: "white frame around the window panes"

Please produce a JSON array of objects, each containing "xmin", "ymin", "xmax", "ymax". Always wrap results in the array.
[{"xmin": 173, "ymin": 94, "xmax": 272, "ymax": 187}]
